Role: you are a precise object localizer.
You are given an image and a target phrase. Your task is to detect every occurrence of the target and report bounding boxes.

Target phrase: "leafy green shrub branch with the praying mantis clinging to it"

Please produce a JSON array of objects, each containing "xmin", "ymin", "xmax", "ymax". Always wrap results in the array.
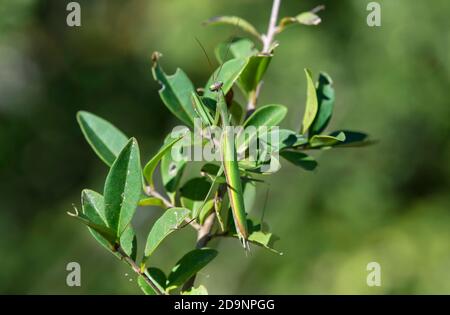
[{"xmin": 71, "ymin": 1, "xmax": 371, "ymax": 295}]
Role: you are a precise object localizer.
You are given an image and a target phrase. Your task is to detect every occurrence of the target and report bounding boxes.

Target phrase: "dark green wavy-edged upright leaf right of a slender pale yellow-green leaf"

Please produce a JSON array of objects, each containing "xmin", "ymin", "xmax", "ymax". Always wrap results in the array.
[{"xmin": 310, "ymin": 73, "xmax": 335, "ymax": 136}]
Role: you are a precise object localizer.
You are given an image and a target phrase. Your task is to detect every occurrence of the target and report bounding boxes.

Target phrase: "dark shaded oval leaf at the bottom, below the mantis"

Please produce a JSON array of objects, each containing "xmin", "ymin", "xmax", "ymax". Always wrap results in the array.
[{"xmin": 167, "ymin": 248, "xmax": 217, "ymax": 290}]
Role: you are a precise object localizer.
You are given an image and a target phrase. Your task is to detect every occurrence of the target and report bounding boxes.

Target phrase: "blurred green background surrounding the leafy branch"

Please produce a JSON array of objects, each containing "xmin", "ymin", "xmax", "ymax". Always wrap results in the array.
[{"xmin": 0, "ymin": 0, "xmax": 450, "ymax": 294}]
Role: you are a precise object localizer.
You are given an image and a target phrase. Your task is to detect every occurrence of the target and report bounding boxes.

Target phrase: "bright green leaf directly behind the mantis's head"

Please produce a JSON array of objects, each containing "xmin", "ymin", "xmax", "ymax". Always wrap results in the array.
[{"xmin": 204, "ymin": 59, "xmax": 248, "ymax": 99}]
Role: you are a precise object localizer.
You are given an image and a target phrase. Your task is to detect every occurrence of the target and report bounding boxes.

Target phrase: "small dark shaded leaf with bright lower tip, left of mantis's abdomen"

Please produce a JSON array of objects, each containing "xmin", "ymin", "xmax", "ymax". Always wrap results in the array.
[{"xmin": 180, "ymin": 177, "xmax": 211, "ymax": 218}]
